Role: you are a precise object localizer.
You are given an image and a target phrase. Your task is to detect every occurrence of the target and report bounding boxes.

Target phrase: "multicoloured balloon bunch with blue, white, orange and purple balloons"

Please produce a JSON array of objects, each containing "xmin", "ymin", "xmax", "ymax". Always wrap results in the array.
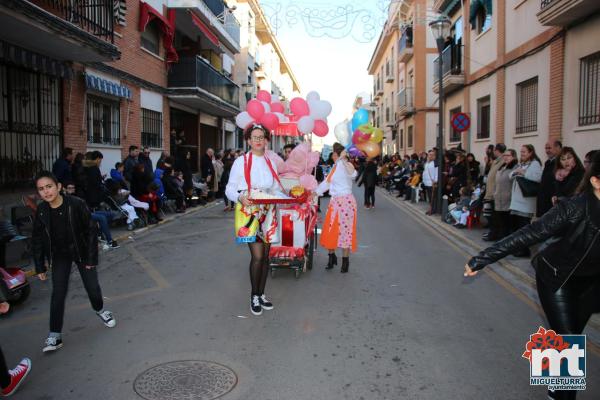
[{"xmin": 334, "ymin": 108, "xmax": 383, "ymax": 158}]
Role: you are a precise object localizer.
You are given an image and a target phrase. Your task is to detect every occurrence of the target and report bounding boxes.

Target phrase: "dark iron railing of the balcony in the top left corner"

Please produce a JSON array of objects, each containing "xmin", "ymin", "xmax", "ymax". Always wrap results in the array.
[{"xmin": 39, "ymin": 0, "xmax": 115, "ymax": 43}]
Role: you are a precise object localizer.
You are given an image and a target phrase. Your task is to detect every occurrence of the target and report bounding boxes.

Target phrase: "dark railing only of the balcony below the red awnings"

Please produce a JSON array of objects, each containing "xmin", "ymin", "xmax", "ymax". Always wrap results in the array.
[{"xmin": 169, "ymin": 56, "xmax": 240, "ymax": 107}]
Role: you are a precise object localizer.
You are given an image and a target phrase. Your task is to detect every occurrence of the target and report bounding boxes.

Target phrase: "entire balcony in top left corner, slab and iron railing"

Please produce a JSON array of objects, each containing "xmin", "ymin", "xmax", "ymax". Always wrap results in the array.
[{"xmin": 0, "ymin": 0, "xmax": 120, "ymax": 62}]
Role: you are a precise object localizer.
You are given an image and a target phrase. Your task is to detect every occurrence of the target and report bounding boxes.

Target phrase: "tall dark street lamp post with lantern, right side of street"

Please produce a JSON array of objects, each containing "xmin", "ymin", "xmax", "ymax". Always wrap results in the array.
[{"xmin": 429, "ymin": 15, "xmax": 451, "ymax": 221}]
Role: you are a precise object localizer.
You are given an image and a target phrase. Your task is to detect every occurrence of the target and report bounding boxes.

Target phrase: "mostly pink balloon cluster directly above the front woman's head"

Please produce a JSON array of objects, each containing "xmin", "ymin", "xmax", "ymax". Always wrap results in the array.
[{"xmin": 235, "ymin": 90, "xmax": 289, "ymax": 131}]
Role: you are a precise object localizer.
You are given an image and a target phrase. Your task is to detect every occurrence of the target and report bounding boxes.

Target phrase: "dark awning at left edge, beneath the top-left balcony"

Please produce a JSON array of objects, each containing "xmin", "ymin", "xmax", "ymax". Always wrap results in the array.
[{"xmin": 0, "ymin": 40, "xmax": 73, "ymax": 79}]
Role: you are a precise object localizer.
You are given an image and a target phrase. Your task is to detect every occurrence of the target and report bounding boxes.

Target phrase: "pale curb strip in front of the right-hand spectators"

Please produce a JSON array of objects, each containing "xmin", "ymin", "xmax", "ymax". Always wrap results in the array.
[{"xmin": 378, "ymin": 188, "xmax": 600, "ymax": 346}]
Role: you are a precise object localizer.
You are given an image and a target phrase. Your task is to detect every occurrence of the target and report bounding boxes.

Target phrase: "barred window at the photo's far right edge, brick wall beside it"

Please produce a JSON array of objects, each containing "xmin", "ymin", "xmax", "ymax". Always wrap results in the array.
[{"xmin": 579, "ymin": 52, "xmax": 600, "ymax": 125}]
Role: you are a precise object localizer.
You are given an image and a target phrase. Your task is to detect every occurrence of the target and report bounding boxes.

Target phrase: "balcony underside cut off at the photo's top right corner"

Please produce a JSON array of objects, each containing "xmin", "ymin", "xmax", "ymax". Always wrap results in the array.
[{"xmin": 537, "ymin": 0, "xmax": 600, "ymax": 26}]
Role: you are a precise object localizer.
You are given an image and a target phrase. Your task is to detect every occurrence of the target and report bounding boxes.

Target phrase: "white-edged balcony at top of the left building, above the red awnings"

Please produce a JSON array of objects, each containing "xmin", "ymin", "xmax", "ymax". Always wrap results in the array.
[{"xmin": 167, "ymin": 0, "xmax": 240, "ymax": 54}]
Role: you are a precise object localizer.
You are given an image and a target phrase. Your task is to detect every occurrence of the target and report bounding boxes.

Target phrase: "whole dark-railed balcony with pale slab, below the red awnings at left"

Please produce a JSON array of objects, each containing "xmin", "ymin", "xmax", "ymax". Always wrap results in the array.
[{"xmin": 169, "ymin": 56, "xmax": 240, "ymax": 117}]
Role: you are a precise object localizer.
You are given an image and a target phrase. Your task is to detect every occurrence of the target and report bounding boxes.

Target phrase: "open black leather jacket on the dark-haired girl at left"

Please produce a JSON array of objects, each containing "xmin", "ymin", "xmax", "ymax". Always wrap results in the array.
[{"xmin": 32, "ymin": 195, "xmax": 98, "ymax": 274}]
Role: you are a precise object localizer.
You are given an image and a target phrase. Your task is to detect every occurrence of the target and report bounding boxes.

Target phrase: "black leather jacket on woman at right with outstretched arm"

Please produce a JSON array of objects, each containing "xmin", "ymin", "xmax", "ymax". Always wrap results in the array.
[{"xmin": 468, "ymin": 194, "xmax": 600, "ymax": 291}]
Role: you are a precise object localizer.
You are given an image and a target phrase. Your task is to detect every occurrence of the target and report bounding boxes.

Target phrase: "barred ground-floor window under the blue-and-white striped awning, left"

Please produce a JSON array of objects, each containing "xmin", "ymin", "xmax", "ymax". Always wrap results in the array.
[{"xmin": 87, "ymin": 95, "xmax": 121, "ymax": 146}]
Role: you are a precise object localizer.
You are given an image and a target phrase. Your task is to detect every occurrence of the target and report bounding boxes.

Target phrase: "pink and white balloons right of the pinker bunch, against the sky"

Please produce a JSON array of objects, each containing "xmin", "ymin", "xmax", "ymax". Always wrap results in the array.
[{"xmin": 290, "ymin": 91, "xmax": 331, "ymax": 137}]
